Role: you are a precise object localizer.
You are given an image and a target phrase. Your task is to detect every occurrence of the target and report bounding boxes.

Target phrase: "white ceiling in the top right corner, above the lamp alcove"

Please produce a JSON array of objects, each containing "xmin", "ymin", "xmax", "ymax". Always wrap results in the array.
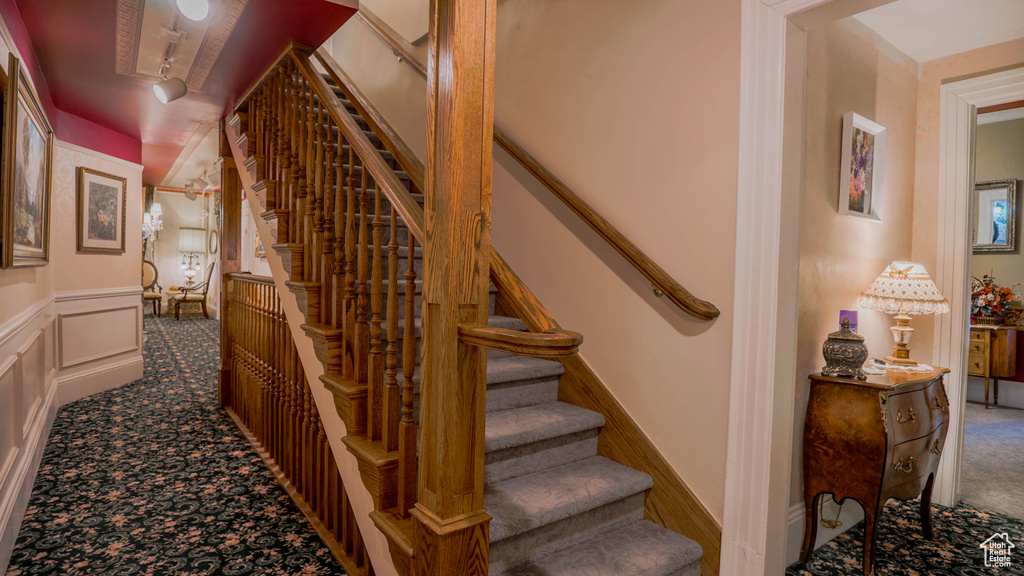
[{"xmin": 853, "ymin": 0, "xmax": 1024, "ymax": 63}]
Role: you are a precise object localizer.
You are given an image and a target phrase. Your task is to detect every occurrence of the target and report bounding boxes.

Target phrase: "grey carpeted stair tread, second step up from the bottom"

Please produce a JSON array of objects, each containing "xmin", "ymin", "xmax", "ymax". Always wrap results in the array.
[{"xmin": 483, "ymin": 456, "xmax": 654, "ymax": 543}]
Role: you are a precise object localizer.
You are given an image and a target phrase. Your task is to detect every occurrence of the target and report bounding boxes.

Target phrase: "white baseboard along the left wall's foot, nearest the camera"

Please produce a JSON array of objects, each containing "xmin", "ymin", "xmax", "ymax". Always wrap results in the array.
[{"xmin": 0, "ymin": 375, "xmax": 57, "ymax": 574}]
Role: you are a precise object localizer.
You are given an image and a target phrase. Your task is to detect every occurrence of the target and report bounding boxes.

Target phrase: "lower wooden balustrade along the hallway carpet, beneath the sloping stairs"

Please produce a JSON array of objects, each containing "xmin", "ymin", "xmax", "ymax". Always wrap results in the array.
[{"xmin": 224, "ymin": 274, "xmax": 374, "ymax": 576}]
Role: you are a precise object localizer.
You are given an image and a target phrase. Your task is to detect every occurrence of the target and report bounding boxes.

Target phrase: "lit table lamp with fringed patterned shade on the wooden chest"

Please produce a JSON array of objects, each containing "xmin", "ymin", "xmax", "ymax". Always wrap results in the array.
[{"xmin": 860, "ymin": 262, "xmax": 949, "ymax": 366}]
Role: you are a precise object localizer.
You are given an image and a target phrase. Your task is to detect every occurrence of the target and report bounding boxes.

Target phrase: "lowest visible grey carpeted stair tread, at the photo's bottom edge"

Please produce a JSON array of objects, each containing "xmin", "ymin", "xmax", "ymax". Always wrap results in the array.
[{"xmin": 502, "ymin": 520, "xmax": 703, "ymax": 576}]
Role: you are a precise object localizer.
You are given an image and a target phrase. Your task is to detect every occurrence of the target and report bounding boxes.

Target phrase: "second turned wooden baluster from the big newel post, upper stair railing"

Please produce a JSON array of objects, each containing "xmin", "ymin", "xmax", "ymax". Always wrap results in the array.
[{"xmin": 383, "ymin": 206, "xmax": 401, "ymax": 452}]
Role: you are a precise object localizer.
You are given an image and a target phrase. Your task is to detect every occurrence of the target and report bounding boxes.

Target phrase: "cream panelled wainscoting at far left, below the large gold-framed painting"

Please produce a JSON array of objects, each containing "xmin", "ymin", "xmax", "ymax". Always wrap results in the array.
[{"xmin": 0, "ymin": 297, "xmax": 57, "ymax": 573}]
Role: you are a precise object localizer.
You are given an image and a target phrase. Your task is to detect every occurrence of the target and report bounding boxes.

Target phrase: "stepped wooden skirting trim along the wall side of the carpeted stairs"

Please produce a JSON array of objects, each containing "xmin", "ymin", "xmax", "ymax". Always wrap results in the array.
[{"xmin": 490, "ymin": 251, "xmax": 722, "ymax": 576}]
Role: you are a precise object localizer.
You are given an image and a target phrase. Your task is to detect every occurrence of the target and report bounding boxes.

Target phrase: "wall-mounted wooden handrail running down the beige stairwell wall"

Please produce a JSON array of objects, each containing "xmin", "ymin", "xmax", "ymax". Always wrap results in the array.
[{"xmin": 348, "ymin": 8, "xmax": 721, "ymax": 320}]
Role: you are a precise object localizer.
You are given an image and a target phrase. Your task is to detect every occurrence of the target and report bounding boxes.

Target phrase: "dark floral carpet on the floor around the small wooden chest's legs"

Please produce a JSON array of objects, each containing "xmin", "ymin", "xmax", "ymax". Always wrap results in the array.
[{"xmin": 786, "ymin": 500, "xmax": 1024, "ymax": 576}]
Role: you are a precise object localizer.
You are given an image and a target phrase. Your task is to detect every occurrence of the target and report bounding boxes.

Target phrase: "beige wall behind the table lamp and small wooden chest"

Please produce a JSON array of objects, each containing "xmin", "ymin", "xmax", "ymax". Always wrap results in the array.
[{"xmin": 791, "ymin": 18, "xmax": 918, "ymax": 503}]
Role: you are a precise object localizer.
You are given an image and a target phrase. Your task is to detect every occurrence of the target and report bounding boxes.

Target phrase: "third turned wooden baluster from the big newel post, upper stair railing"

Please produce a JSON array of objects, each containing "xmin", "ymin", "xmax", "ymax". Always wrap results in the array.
[{"xmin": 364, "ymin": 181, "xmax": 385, "ymax": 440}]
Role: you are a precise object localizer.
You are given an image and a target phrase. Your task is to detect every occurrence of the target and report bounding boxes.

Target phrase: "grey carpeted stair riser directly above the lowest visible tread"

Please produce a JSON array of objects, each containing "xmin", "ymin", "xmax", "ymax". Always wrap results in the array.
[{"xmin": 488, "ymin": 492, "xmax": 644, "ymax": 576}]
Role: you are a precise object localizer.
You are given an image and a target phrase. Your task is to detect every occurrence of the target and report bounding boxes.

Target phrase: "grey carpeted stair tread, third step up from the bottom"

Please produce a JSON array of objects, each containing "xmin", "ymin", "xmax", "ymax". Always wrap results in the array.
[{"xmin": 483, "ymin": 402, "xmax": 604, "ymax": 452}]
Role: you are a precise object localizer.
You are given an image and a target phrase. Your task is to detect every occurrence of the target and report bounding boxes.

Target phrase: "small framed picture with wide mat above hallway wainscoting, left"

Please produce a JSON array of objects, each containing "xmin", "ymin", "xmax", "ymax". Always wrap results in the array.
[{"xmin": 78, "ymin": 166, "xmax": 128, "ymax": 254}]
